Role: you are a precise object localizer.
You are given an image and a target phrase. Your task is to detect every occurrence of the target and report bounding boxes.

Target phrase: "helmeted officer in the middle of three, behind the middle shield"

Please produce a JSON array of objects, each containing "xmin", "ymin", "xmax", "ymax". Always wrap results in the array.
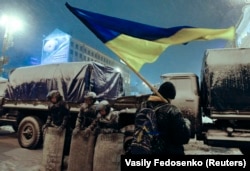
[{"xmin": 73, "ymin": 92, "xmax": 98, "ymax": 135}]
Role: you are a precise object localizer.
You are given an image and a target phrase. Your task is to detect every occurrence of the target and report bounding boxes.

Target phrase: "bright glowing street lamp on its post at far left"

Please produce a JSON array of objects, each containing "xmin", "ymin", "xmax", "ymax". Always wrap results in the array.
[{"xmin": 0, "ymin": 15, "xmax": 21, "ymax": 75}]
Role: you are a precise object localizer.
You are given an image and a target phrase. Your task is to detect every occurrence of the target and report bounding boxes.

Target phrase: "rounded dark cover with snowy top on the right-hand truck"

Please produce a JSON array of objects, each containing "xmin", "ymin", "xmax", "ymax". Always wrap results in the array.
[{"xmin": 201, "ymin": 48, "xmax": 250, "ymax": 111}]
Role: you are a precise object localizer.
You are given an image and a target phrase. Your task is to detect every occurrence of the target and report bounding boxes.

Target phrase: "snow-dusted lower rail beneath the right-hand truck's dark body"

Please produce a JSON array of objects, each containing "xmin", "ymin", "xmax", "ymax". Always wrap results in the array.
[{"xmin": 204, "ymin": 129, "xmax": 250, "ymax": 148}]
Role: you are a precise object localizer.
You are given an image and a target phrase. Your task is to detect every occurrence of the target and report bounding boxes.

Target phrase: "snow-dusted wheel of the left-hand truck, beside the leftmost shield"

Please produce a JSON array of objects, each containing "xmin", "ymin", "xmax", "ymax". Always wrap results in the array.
[{"xmin": 17, "ymin": 116, "xmax": 43, "ymax": 149}]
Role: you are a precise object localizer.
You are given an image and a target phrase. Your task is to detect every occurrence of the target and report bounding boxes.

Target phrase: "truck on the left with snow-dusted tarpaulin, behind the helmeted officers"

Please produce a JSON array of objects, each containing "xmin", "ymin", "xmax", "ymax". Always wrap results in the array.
[{"xmin": 0, "ymin": 62, "xmax": 124, "ymax": 149}]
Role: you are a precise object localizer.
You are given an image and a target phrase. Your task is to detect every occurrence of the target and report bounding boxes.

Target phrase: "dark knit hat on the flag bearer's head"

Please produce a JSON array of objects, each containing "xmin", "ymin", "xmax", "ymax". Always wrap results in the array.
[{"xmin": 158, "ymin": 81, "xmax": 176, "ymax": 99}]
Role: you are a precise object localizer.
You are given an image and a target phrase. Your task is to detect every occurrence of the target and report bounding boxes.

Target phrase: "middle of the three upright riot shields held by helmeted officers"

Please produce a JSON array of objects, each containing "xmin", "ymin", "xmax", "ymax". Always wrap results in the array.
[{"xmin": 67, "ymin": 130, "xmax": 96, "ymax": 171}]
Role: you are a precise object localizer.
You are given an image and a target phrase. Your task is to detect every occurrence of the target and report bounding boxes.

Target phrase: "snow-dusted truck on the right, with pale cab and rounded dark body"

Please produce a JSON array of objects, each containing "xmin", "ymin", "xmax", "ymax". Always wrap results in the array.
[{"xmin": 161, "ymin": 48, "xmax": 250, "ymax": 154}]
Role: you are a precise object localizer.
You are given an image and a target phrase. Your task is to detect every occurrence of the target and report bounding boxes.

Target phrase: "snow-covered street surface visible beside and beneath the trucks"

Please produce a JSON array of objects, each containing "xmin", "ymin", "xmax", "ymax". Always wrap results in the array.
[{"xmin": 0, "ymin": 127, "xmax": 242, "ymax": 171}]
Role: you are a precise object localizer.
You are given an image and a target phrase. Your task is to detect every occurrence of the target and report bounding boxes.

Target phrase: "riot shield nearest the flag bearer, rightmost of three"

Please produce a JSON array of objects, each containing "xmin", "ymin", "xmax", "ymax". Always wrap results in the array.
[{"xmin": 93, "ymin": 133, "xmax": 124, "ymax": 171}]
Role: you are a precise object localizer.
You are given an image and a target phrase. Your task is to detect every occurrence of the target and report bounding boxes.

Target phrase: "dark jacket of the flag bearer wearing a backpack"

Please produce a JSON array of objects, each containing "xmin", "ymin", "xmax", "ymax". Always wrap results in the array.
[{"xmin": 146, "ymin": 97, "xmax": 190, "ymax": 155}]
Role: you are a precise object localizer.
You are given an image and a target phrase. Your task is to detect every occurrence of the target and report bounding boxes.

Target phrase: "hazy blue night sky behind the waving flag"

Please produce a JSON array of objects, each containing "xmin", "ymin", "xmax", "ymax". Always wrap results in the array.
[{"xmin": 0, "ymin": 0, "xmax": 250, "ymax": 90}]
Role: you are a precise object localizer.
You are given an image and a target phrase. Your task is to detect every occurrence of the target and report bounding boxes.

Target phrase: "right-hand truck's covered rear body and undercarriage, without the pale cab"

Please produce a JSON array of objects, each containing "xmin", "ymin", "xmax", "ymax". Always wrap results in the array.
[{"xmin": 201, "ymin": 48, "xmax": 250, "ymax": 155}]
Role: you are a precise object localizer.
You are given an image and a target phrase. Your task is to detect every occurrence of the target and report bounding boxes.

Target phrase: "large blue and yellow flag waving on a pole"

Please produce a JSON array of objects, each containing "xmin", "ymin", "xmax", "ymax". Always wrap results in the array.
[{"xmin": 65, "ymin": 3, "xmax": 235, "ymax": 72}]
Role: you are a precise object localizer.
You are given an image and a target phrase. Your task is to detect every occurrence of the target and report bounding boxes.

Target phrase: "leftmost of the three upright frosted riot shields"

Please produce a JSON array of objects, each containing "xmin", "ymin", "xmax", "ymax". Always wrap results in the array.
[{"xmin": 42, "ymin": 127, "xmax": 66, "ymax": 171}]
